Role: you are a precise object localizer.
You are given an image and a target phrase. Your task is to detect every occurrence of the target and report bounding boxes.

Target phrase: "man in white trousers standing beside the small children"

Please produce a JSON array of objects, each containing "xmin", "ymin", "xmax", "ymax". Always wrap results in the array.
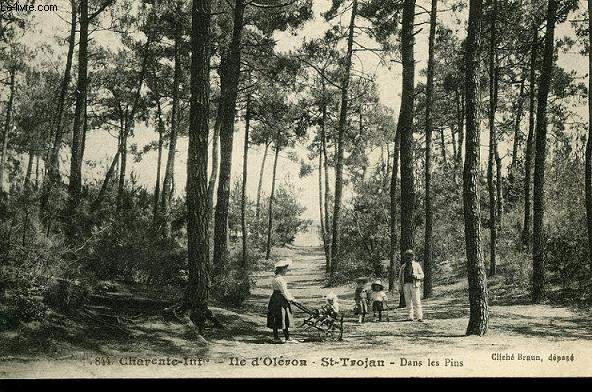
[{"xmin": 399, "ymin": 249, "xmax": 423, "ymax": 322}]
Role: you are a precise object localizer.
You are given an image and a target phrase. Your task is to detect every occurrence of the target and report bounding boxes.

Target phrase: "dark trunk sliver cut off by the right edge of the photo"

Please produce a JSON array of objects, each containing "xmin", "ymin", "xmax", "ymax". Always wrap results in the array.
[{"xmin": 585, "ymin": 0, "xmax": 592, "ymax": 263}]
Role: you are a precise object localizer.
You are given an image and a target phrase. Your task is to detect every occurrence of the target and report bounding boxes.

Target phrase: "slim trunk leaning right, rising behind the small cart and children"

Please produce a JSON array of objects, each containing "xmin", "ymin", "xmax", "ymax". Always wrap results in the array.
[{"xmin": 329, "ymin": 0, "xmax": 358, "ymax": 285}]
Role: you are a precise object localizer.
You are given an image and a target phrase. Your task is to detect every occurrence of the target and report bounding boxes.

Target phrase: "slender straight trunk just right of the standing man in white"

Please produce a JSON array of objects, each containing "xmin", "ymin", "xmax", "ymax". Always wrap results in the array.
[{"xmin": 423, "ymin": 0, "xmax": 438, "ymax": 298}]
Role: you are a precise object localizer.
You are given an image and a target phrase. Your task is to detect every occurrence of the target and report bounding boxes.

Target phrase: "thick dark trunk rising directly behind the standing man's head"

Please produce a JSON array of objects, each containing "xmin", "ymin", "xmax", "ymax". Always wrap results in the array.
[{"xmin": 398, "ymin": 0, "xmax": 415, "ymax": 261}]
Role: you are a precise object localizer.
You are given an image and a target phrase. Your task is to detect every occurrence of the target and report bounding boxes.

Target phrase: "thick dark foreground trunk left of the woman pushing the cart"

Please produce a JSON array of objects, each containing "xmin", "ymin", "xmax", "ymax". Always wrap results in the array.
[{"xmin": 185, "ymin": 0, "xmax": 213, "ymax": 333}]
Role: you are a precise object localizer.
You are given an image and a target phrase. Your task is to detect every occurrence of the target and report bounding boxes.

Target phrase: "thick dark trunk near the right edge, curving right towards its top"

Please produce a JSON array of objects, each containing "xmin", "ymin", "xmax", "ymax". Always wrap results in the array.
[{"xmin": 532, "ymin": 0, "xmax": 557, "ymax": 303}]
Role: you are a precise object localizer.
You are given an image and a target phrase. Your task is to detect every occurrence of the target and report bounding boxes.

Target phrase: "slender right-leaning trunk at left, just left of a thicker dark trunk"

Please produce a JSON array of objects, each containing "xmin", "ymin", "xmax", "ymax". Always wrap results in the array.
[{"xmin": 39, "ymin": 0, "xmax": 77, "ymax": 220}]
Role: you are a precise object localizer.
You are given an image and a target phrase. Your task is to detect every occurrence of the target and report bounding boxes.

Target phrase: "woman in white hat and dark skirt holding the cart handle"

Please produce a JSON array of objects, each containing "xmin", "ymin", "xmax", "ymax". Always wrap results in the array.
[{"xmin": 267, "ymin": 260, "xmax": 294, "ymax": 343}]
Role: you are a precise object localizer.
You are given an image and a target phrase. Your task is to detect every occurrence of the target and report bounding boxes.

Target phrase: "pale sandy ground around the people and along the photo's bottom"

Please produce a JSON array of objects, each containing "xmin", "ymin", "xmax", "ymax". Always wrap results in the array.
[{"xmin": 0, "ymin": 247, "xmax": 592, "ymax": 377}]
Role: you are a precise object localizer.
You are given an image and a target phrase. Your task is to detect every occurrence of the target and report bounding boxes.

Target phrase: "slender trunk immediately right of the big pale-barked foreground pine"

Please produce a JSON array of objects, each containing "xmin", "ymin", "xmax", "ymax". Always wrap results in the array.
[{"xmin": 487, "ymin": 0, "xmax": 497, "ymax": 276}]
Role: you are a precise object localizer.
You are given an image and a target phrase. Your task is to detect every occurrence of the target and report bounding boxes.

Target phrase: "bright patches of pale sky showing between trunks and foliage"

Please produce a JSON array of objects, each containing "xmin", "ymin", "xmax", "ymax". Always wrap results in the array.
[{"xmin": 9, "ymin": 0, "xmax": 587, "ymax": 220}]
